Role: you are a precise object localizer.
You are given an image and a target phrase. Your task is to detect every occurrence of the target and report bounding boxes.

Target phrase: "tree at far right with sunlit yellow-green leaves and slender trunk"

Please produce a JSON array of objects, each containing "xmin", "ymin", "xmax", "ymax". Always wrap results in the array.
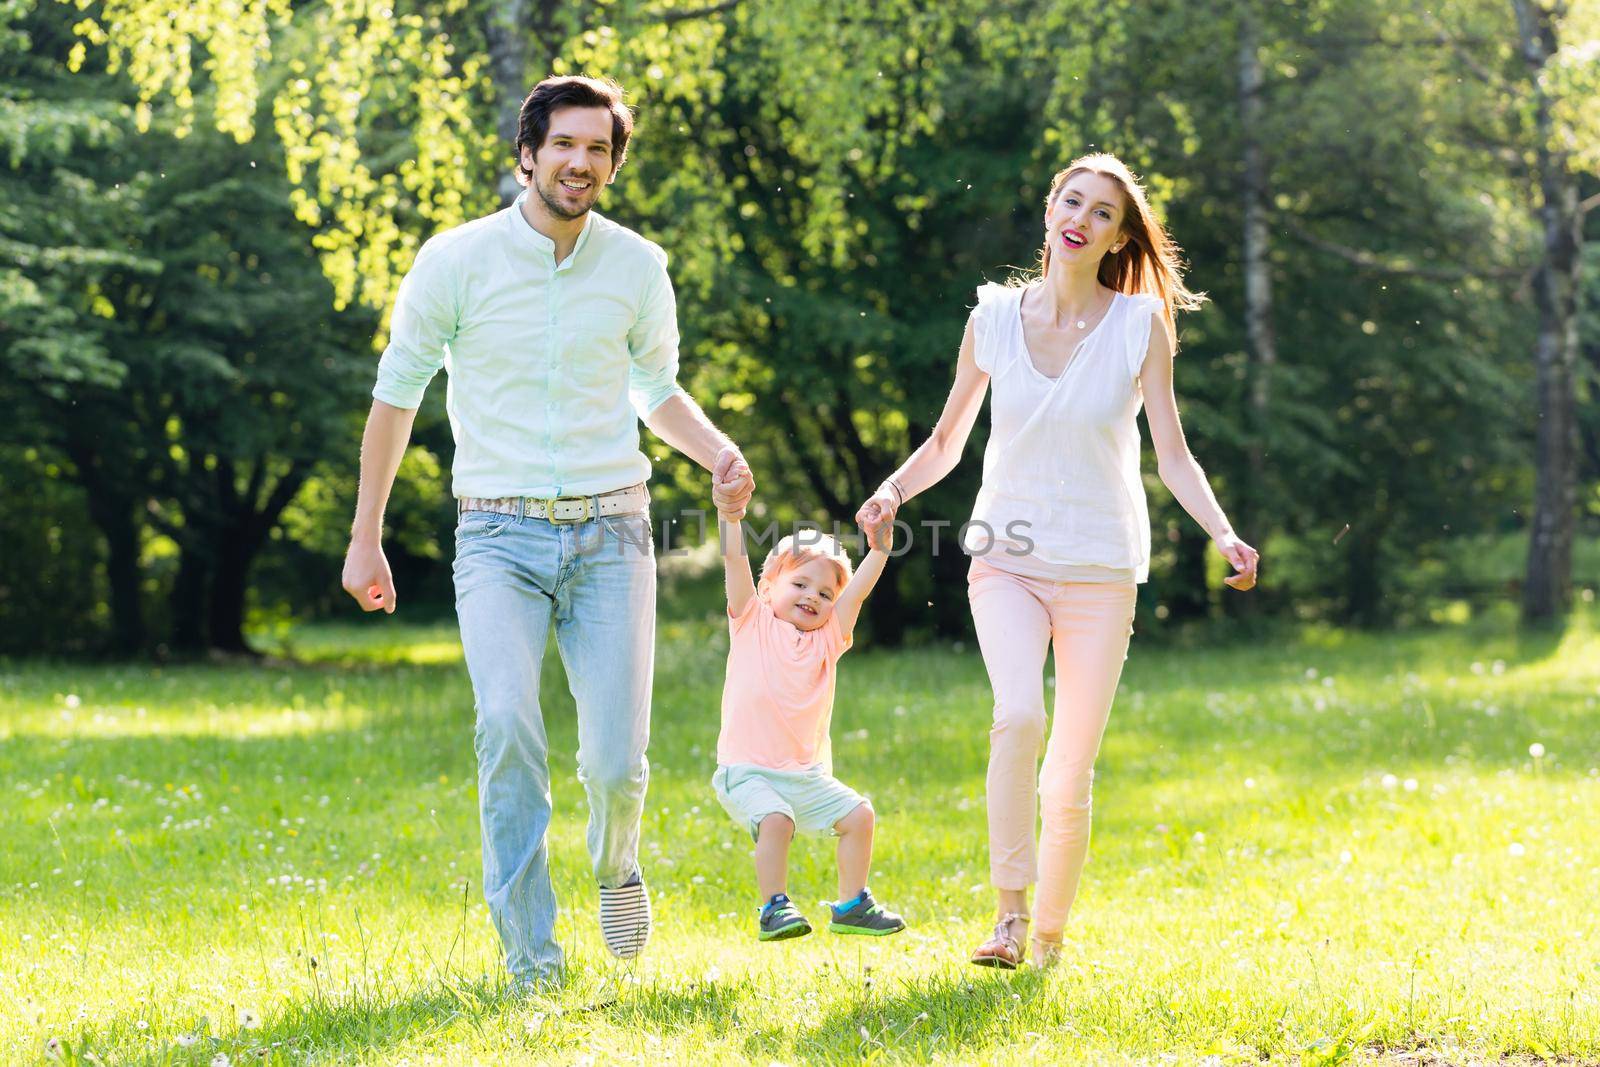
[{"xmin": 1273, "ymin": 0, "xmax": 1600, "ymax": 621}]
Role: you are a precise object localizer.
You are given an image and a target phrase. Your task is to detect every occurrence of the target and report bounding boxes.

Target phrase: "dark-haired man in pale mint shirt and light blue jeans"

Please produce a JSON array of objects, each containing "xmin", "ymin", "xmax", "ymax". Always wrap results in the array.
[{"xmin": 344, "ymin": 77, "xmax": 754, "ymax": 984}]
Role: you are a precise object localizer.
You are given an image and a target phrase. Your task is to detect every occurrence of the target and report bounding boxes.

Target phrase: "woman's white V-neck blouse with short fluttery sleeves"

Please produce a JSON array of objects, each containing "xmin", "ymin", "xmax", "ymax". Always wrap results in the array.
[{"xmin": 962, "ymin": 285, "xmax": 1162, "ymax": 582}]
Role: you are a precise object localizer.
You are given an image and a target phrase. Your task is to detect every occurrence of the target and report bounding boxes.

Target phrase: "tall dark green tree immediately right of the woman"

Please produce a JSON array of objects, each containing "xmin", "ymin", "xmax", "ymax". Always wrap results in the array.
[{"xmin": 1096, "ymin": 0, "xmax": 1528, "ymax": 624}]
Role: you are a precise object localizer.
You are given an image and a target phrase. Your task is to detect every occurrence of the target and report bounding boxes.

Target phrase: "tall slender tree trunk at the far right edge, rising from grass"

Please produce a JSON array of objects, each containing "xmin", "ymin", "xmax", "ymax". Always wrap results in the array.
[{"xmin": 1517, "ymin": 0, "xmax": 1582, "ymax": 622}]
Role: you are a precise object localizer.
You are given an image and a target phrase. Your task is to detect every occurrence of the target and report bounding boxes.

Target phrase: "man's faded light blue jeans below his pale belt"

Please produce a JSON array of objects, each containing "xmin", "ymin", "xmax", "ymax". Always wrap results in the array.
[{"xmin": 454, "ymin": 512, "xmax": 656, "ymax": 981}]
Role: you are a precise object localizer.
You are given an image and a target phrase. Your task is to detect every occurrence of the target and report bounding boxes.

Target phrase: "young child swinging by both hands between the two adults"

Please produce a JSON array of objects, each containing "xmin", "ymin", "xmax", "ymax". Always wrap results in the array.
[{"xmin": 712, "ymin": 470, "xmax": 906, "ymax": 941}]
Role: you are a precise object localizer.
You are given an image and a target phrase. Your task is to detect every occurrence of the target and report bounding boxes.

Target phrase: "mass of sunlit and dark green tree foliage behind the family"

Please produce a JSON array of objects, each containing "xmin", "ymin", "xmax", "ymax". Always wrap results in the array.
[{"xmin": 0, "ymin": 0, "xmax": 1600, "ymax": 652}]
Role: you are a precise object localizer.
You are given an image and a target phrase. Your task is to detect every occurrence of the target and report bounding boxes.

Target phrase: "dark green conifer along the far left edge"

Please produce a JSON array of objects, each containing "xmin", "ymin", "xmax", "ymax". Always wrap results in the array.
[{"xmin": 0, "ymin": 0, "xmax": 160, "ymax": 649}]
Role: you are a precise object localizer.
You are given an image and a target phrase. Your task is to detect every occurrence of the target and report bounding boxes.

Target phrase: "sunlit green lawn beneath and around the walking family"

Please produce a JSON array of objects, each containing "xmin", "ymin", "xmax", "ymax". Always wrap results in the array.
[{"xmin": 0, "ymin": 611, "xmax": 1600, "ymax": 1064}]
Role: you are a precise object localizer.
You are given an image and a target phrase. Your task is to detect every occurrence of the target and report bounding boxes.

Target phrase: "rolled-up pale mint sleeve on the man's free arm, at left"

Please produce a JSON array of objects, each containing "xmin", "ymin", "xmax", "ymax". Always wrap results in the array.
[{"xmin": 373, "ymin": 242, "xmax": 459, "ymax": 408}]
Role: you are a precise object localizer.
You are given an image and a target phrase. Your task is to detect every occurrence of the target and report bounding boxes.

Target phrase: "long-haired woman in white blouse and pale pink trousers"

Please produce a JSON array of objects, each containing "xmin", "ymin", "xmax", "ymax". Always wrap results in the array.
[{"xmin": 856, "ymin": 154, "xmax": 1258, "ymax": 969}]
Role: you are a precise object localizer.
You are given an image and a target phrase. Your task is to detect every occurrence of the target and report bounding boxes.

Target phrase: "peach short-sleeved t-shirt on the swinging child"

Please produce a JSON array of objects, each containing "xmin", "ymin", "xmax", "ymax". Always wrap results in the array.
[{"xmin": 717, "ymin": 597, "xmax": 850, "ymax": 771}]
